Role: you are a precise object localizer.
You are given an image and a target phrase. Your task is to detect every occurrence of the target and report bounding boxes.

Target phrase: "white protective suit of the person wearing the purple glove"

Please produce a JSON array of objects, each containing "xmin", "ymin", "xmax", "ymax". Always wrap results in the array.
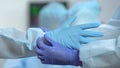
[{"xmin": 79, "ymin": 7, "xmax": 120, "ymax": 68}]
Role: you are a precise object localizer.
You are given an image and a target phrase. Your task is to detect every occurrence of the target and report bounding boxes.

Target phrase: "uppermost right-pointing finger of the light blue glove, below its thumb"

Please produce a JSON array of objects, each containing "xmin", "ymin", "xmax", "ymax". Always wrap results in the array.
[{"xmin": 79, "ymin": 22, "xmax": 100, "ymax": 29}]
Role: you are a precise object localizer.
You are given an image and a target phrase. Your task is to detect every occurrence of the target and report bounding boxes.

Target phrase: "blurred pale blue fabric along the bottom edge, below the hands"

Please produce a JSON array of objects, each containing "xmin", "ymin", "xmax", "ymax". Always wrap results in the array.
[{"xmin": 3, "ymin": 56, "xmax": 80, "ymax": 68}]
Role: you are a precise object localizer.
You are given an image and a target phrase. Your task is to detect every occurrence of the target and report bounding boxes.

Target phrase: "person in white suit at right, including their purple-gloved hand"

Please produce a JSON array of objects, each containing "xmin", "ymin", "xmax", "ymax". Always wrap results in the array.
[{"xmin": 36, "ymin": 7, "xmax": 120, "ymax": 68}]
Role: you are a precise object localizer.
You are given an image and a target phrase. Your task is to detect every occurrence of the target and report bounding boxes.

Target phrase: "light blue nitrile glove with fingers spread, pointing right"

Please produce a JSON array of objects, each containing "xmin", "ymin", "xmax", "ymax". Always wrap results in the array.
[{"xmin": 45, "ymin": 17, "xmax": 103, "ymax": 49}]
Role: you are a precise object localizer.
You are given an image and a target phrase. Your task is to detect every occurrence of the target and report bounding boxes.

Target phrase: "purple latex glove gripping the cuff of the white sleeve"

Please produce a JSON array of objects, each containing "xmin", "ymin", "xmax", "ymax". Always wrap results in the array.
[{"xmin": 35, "ymin": 35, "xmax": 82, "ymax": 66}]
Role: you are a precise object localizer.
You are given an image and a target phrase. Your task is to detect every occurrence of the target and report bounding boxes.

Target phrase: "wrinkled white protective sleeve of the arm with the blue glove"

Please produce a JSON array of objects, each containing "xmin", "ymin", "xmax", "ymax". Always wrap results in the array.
[{"xmin": 0, "ymin": 28, "xmax": 44, "ymax": 59}]
